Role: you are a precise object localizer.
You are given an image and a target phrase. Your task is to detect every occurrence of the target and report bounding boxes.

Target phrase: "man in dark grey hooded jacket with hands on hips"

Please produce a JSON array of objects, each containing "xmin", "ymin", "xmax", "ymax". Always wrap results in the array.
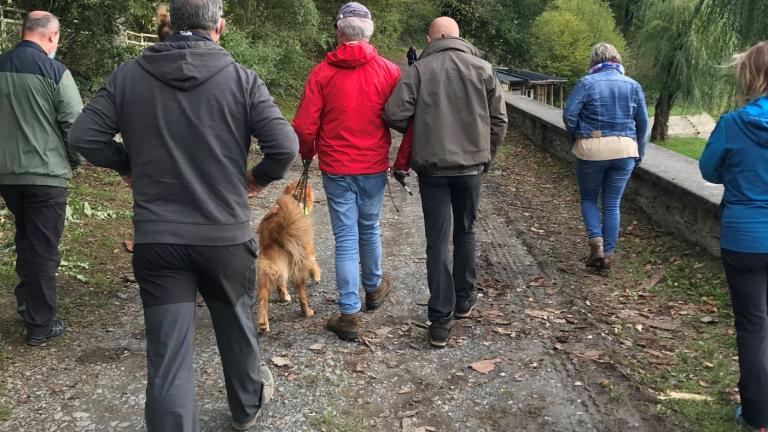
[{"xmin": 70, "ymin": 0, "xmax": 298, "ymax": 432}]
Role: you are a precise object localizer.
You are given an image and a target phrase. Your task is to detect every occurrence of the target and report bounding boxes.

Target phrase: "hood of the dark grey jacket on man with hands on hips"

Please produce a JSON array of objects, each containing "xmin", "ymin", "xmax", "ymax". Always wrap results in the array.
[{"xmin": 137, "ymin": 35, "xmax": 235, "ymax": 90}]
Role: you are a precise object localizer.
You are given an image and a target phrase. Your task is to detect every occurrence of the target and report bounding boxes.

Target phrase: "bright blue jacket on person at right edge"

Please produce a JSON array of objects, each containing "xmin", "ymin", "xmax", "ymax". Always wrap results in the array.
[{"xmin": 699, "ymin": 97, "xmax": 768, "ymax": 253}]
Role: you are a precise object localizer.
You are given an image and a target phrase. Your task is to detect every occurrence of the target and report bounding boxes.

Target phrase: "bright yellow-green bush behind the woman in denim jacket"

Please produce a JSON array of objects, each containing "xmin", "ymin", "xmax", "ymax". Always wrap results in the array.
[{"xmin": 532, "ymin": 0, "xmax": 626, "ymax": 82}]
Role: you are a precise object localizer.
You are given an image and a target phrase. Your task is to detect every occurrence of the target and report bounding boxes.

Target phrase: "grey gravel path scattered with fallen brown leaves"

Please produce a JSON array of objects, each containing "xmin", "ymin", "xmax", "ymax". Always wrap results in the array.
[{"xmin": 0, "ymin": 135, "xmax": 676, "ymax": 432}]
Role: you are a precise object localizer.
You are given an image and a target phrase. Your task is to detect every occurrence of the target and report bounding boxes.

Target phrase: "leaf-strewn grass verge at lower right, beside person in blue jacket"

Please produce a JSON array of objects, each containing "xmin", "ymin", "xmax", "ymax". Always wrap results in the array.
[{"xmin": 618, "ymin": 234, "xmax": 739, "ymax": 432}]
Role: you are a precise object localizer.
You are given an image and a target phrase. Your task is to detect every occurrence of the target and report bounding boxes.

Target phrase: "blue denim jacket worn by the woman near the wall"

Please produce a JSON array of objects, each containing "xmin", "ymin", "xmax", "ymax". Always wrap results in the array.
[{"xmin": 563, "ymin": 70, "xmax": 648, "ymax": 159}]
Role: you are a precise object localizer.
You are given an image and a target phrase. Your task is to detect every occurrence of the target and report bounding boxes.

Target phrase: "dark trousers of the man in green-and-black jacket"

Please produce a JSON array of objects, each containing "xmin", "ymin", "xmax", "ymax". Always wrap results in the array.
[{"xmin": 0, "ymin": 185, "xmax": 67, "ymax": 336}]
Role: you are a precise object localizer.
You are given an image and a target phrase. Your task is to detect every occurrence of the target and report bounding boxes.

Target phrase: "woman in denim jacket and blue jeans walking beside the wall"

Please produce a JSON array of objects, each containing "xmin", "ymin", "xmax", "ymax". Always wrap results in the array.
[{"xmin": 563, "ymin": 43, "xmax": 648, "ymax": 269}]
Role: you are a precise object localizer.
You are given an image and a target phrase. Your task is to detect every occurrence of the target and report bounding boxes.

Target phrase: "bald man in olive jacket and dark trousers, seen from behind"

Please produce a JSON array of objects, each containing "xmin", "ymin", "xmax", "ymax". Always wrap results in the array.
[{"xmin": 384, "ymin": 17, "xmax": 507, "ymax": 348}]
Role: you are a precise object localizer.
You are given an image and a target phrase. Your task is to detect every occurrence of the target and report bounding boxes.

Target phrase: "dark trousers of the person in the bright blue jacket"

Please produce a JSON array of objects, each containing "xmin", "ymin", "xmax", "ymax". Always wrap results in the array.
[{"xmin": 721, "ymin": 249, "xmax": 768, "ymax": 427}]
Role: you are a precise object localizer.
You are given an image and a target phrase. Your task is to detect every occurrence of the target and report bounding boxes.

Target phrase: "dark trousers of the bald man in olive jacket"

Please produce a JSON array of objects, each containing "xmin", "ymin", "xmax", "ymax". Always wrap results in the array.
[{"xmin": 419, "ymin": 175, "xmax": 483, "ymax": 321}]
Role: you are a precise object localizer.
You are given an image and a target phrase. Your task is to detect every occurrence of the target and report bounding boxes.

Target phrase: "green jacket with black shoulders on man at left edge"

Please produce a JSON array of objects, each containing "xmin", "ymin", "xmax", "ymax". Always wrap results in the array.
[{"xmin": 0, "ymin": 41, "xmax": 83, "ymax": 187}]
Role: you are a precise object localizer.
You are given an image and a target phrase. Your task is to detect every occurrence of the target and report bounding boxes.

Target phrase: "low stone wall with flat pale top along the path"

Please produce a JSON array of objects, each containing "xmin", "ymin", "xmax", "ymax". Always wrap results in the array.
[{"xmin": 506, "ymin": 94, "xmax": 723, "ymax": 256}]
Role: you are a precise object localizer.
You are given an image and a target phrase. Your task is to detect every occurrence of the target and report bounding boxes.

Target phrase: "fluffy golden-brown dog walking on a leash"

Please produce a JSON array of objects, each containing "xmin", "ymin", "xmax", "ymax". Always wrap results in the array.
[{"xmin": 258, "ymin": 183, "xmax": 320, "ymax": 332}]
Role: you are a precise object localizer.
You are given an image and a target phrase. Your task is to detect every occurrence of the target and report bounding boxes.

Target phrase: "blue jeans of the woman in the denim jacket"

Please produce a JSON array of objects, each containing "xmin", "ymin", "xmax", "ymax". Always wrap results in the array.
[{"xmin": 576, "ymin": 158, "xmax": 635, "ymax": 253}]
